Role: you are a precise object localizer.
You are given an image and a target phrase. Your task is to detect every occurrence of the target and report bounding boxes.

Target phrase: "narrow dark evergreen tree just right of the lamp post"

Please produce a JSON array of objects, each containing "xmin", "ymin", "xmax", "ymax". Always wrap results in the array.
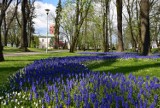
[{"xmin": 54, "ymin": 0, "xmax": 62, "ymax": 47}]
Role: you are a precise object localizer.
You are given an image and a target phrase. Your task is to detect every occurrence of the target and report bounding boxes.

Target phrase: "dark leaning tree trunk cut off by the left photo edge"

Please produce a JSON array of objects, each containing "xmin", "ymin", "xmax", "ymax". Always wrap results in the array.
[{"xmin": 0, "ymin": 0, "xmax": 12, "ymax": 61}]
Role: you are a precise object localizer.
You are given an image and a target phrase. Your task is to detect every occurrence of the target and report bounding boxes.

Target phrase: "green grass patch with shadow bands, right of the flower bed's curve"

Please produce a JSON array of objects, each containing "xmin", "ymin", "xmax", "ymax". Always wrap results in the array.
[{"xmin": 86, "ymin": 59, "xmax": 160, "ymax": 78}]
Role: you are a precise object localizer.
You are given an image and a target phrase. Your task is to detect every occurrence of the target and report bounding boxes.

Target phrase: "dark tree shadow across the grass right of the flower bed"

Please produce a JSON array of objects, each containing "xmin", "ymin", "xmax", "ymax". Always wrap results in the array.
[{"xmin": 87, "ymin": 60, "xmax": 160, "ymax": 74}]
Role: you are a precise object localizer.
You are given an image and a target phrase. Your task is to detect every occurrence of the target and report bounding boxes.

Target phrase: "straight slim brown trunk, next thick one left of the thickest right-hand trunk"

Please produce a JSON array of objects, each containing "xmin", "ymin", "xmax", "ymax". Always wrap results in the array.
[{"xmin": 116, "ymin": 0, "xmax": 124, "ymax": 52}]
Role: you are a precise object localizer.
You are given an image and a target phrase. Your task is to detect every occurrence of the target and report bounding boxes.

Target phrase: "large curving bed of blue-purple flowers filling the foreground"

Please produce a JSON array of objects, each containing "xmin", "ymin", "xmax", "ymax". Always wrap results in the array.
[{"xmin": 0, "ymin": 53, "xmax": 160, "ymax": 108}]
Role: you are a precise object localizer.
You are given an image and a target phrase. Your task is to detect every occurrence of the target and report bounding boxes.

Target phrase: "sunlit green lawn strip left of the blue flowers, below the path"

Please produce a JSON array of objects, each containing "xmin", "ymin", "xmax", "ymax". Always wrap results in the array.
[{"xmin": 0, "ymin": 52, "xmax": 79, "ymax": 86}]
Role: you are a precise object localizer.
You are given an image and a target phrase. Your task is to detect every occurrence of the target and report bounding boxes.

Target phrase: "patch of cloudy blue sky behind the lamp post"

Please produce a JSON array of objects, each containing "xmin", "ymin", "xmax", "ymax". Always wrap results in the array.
[{"xmin": 33, "ymin": 0, "xmax": 58, "ymax": 35}]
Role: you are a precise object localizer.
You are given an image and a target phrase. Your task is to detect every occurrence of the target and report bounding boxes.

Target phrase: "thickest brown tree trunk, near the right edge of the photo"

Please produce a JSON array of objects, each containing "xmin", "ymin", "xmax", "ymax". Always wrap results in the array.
[{"xmin": 140, "ymin": 0, "xmax": 150, "ymax": 55}]
